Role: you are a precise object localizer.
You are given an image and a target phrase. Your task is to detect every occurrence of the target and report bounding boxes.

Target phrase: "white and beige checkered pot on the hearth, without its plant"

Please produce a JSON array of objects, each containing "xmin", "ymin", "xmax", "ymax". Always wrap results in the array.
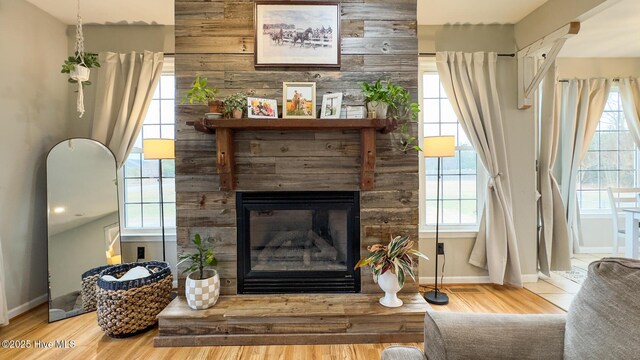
[{"xmin": 184, "ymin": 269, "xmax": 220, "ymax": 310}]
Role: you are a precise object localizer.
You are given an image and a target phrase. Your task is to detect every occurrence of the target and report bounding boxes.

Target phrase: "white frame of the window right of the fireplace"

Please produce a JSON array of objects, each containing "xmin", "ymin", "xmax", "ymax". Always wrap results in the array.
[{"xmin": 418, "ymin": 57, "xmax": 488, "ymax": 238}]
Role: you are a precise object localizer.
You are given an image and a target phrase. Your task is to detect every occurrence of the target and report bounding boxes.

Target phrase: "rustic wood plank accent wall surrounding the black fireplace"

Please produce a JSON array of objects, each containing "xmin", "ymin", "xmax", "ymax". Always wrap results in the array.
[{"xmin": 175, "ymin": 0, "xmax": 418, "ymax": 294}]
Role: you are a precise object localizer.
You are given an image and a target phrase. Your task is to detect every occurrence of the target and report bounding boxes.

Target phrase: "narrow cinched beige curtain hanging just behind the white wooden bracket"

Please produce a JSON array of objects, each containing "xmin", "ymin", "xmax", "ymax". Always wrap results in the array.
[{"xmin": 538, "ymin": 64, "xmax": 571, "ymax": 276}]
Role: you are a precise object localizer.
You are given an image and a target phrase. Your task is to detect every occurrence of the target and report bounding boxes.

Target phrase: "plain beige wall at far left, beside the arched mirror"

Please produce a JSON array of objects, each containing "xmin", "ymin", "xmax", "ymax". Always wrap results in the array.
[{"xmin": 0, "ymin": 0, "xmax": 68, "ymax": 309}]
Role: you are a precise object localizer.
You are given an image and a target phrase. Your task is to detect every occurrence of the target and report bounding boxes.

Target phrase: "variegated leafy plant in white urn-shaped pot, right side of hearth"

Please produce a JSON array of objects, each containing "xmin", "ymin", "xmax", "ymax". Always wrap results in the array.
[{"xmin": 355, "ymin": 236, "xmax": 429, "ymax": 307}]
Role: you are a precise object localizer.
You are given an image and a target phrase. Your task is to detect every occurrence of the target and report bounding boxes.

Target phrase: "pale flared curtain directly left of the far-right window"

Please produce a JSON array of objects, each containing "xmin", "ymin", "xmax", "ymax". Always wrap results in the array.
[{"xmin": 560, "ymin": 79, "xmax": 611, "ymax": 253}]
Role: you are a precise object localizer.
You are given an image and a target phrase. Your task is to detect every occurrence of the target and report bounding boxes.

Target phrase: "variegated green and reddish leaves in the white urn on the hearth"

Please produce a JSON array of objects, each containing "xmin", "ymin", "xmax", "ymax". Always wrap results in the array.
[{"xmin": 355, "ymin": 236, "xmax": 429, "ymax": 287}]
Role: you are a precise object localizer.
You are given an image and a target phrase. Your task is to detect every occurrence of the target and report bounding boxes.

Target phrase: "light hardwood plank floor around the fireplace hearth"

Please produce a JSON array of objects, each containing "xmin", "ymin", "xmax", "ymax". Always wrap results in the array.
[{"xmin": 0, "ymin": 285, "xmax": 563, "ymax": 360}]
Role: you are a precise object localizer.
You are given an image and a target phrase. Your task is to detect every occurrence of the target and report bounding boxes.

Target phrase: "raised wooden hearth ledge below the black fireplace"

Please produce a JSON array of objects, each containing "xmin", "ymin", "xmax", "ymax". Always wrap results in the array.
[{"xmin": 154, "ymin": 293, "xmax": 431, "ymax": 347}]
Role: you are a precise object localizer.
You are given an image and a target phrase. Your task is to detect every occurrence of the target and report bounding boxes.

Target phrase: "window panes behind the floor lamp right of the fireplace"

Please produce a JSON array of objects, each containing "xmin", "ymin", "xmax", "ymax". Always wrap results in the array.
[{"xmin": 422, "ymin": 72, "xmax": 484, "ymax": 231}]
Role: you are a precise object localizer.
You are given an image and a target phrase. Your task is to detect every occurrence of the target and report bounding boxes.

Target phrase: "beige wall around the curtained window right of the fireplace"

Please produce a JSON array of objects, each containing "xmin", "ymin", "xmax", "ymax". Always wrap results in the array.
[{"xmin": 418, "ymin": 25, "xmax": 537, "ymax": 282}]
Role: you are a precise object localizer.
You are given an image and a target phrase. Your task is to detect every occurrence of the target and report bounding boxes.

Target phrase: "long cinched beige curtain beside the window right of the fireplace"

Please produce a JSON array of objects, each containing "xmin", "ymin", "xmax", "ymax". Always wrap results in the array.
[{"xmin": 436, "ymin": 52, "xmax": 522, "ymax": 286}]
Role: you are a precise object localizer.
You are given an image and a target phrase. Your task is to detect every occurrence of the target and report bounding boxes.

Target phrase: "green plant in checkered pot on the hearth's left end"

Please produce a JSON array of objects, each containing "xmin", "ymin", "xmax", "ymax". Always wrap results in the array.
[{"xmin": 178, "ymin": 234, "xmax": 220, "ymax": 310}]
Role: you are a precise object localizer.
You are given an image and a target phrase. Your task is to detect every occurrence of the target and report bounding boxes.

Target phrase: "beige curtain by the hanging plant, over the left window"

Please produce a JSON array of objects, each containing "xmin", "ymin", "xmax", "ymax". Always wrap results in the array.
[{"xmin": 91, "ymin": 51, "xmax": 164, "ymax": 167}]
